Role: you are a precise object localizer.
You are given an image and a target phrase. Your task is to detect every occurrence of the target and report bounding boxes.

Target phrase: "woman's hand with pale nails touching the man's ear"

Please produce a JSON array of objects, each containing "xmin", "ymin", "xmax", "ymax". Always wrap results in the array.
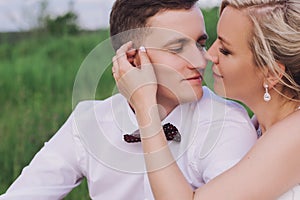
[{"xmin": 112, "ymin": 42, "xmax": 157, "ymax": 109}]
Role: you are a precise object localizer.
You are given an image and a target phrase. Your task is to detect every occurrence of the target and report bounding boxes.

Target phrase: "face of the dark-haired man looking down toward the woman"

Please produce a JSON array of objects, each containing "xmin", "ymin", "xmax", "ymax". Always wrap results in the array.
[{"xmin": 143, "ymin": 7, "xmax": 207, "ymax": 109}]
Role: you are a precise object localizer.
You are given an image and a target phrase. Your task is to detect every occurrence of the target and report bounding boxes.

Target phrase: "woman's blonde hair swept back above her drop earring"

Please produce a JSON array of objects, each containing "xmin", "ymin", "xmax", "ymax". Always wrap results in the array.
[{"xmin": 220, "ymin": 0, "xmax": 300, "ymax": 100}]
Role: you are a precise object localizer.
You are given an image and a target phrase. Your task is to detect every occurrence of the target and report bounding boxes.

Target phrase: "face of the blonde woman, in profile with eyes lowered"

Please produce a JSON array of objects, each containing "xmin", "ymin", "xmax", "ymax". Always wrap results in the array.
[{"xmin": 208, "ymin": 7, "xmax": 264, "ymax": 104}]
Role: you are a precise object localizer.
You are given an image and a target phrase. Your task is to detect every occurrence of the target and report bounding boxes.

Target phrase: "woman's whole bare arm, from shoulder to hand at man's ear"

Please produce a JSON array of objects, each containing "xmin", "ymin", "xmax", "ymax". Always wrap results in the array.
[{"xmin": 114, "ymin": 44, "xmax": 300, "ymax": 200}]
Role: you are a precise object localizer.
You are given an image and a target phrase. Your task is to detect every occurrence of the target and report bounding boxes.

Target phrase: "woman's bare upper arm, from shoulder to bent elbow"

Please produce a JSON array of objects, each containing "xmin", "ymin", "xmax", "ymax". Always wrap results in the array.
[{"xmin": 195, "ymin": 113, "xmax": 300, "ymax": 200}]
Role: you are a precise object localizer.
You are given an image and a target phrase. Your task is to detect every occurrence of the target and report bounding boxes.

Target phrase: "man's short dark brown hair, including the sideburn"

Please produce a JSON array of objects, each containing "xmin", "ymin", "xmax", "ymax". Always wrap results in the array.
[{"xmin": 110, "ymin": 0, "xmax": 198, "ymax": 50}]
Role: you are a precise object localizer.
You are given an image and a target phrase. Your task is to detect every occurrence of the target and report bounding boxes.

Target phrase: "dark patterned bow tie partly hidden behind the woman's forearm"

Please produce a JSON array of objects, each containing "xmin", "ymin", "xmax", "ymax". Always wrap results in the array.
[{"xmin": 124, "ymin": 123, "xmax": 181, "ymax": 143}]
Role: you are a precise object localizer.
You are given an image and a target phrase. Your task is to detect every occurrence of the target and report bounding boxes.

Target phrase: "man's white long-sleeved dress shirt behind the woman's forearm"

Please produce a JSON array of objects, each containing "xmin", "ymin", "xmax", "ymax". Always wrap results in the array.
[{"xmin": 0, "ymin": 87, "xmax": 257, "ymax": 200}]
